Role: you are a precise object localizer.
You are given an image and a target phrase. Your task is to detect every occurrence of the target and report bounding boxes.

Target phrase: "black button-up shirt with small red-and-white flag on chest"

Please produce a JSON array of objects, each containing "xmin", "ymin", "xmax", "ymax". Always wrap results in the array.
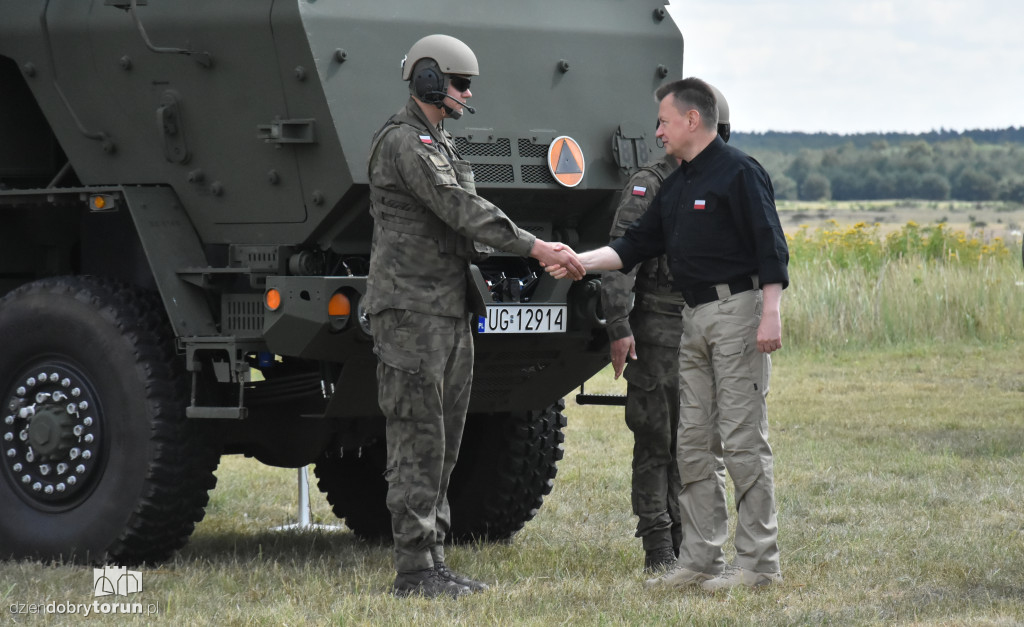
[{"xmin": 610, "ymin": 136, "xmax": 790, "ymax": 291}]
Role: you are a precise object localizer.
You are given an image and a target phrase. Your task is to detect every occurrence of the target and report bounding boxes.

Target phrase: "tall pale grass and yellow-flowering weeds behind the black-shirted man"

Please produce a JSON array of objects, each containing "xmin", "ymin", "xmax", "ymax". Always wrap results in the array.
[{"xmin": 782, "ymin": 222, "xmax": 1024, "ymax": 349}]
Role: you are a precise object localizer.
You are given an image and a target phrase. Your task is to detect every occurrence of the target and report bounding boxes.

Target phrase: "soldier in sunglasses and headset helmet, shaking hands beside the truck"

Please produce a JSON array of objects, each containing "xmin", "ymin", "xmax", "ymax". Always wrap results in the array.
[{"xmin": 366, "ymin": 35, "xmax": 584, "ymax": 597}]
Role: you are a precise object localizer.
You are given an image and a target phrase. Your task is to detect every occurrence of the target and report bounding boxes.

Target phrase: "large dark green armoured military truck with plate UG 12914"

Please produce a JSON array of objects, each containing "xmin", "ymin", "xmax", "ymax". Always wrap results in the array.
[{"xmin": 0, "ymin": 0, "xmax": 682, "ymax": 563}]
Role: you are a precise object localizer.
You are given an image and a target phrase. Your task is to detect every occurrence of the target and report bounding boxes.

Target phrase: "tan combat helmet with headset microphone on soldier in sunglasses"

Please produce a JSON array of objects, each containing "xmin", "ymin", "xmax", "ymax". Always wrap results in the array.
[{"xmin": 401, "ymin": 35, "xmax": 480, "ymax": 118}]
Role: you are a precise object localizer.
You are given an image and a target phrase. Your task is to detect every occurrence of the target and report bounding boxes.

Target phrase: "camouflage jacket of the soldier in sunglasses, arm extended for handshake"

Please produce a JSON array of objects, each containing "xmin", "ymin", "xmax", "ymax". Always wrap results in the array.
[{"xmin": 365, "ymin": 98, "xmax": 536, "ymax": 317}]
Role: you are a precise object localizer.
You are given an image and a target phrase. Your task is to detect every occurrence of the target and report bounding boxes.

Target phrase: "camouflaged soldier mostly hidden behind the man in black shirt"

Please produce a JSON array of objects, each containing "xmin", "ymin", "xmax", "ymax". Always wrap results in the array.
[{"xmin": 601, "ymin": 87, "xmax": 730, "ymax": 573}]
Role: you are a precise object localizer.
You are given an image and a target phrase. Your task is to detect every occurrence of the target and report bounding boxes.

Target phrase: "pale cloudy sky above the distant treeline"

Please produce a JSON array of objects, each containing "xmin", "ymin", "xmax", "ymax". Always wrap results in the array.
[{"xmin": 669, "ymin": 0, "xmax": 1024, "ymax": 134}]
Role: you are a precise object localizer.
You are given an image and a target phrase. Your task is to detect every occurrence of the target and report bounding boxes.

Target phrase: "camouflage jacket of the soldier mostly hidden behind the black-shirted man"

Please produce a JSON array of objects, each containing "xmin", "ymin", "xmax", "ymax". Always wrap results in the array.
[{"xmin": 601, "ymin": 155, "xmax": 683, "ymax": 346}]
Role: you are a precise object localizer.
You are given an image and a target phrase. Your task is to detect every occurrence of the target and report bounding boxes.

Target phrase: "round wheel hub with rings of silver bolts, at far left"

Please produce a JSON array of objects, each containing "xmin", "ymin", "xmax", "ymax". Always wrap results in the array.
[{"xmin": 0, "ymin": 364, "xmax": 101, "ymax": 503}]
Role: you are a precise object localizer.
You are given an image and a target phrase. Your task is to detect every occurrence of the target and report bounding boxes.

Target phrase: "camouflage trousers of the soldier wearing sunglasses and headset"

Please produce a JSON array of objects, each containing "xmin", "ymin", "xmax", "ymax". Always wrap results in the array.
[{"xmin": 370, "ymin": 309, "xmax": 473, "ymax": 573}]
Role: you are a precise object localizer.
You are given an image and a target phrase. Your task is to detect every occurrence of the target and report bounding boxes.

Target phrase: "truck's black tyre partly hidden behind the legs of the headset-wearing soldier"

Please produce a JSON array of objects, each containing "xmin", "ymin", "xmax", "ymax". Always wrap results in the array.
[{"xmin": 315, "ymin": 401, "xmax": 565, "ymax": 541}]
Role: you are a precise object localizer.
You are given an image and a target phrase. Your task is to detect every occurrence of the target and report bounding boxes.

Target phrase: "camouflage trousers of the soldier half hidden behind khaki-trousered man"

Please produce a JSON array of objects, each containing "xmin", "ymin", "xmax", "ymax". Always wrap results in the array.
[{"xmin": 625, "ymin": 340, "xmax": 681, "ymax": 551}]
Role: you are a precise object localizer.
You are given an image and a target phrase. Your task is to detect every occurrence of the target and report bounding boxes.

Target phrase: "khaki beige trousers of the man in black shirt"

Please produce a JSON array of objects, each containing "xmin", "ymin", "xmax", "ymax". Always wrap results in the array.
[{"xmin": 677, "ymin": 290, "xmax": 779, "ymax": 573}]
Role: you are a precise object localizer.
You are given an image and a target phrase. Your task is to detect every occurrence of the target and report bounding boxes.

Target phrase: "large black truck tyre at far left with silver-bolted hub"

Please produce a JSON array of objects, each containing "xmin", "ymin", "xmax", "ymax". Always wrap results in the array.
[{"xmin": 0, "ymin": 277, "xmax": 219, "ymax": 565}]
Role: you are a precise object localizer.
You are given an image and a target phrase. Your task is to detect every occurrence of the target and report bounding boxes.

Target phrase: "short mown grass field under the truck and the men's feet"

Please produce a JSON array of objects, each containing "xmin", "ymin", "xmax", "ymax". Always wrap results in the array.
[{"xmin": 0, "ymin": 341, "xmax": 1024, "ymax": 626}]
